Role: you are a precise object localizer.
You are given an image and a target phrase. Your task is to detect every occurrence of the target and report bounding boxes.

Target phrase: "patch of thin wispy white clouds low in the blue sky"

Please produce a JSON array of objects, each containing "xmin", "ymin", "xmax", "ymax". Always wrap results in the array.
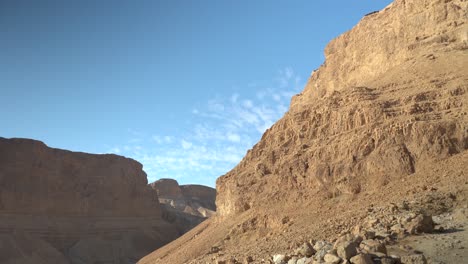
[{"xmin": 106, "ymin": 68, "xmax": 302, "ymax": 186}]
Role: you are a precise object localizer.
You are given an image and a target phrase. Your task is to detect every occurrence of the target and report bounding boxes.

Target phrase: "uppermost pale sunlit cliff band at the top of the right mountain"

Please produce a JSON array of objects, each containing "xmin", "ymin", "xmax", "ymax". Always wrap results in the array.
[{"xmin": 291, "ymin": 0, "xmax": 468, "ymax": 102}]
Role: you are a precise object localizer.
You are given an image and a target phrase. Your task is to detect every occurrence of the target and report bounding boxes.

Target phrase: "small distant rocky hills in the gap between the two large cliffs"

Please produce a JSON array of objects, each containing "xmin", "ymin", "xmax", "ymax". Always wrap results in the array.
[{"xmin": 150, "ymin": 179, "xmax": 216, "ymax": 234}]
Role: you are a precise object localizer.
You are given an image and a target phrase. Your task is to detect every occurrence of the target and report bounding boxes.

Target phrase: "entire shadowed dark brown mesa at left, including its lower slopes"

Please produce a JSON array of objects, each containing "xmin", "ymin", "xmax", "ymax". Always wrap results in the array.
[{"xmin": 0, "ymin": 138, "xmax": 178, "ymax": 263}]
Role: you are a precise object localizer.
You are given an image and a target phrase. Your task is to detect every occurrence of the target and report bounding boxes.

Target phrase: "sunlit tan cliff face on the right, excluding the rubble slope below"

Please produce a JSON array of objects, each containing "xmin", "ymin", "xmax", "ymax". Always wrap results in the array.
[{"xmin": 216, "ymin": 0, "xmax": 468, "ymax": 216}]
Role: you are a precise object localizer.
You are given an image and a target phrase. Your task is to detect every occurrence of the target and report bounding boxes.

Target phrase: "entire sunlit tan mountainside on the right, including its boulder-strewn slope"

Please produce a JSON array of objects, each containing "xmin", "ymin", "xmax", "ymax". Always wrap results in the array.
[{"xmin": 139, "ymin": 0, "xmax": 468, "ymax": 264}]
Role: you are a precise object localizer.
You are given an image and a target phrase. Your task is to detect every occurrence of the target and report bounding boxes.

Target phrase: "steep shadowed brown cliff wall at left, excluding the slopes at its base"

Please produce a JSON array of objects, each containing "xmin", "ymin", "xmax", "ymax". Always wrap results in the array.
[{"xmin": 0, "ymin": 138, "xmax": 160, "ymax": 216}]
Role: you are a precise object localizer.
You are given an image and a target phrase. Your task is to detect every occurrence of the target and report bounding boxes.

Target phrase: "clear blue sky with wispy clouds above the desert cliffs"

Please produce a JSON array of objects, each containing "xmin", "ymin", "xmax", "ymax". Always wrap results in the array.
[{"xmin": 0, "ymin": 0, "xmax": 391, "ymax": 186}]
